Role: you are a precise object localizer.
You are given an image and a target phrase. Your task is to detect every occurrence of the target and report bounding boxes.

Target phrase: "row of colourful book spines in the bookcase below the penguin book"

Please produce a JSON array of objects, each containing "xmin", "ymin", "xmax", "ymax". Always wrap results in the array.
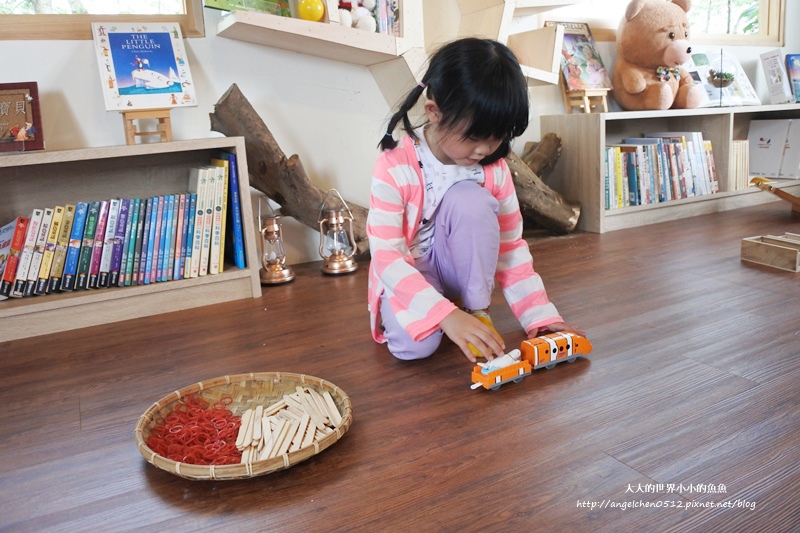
[{"xmin": 0, "ymin": 152, "xmax": 245, "ymax": 300}]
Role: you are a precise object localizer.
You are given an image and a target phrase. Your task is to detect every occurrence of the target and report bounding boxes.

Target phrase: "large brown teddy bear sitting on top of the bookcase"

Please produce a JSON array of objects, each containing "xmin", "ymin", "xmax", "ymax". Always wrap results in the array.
[{"xmin": 612, "ymin": 0, "xmax": 703, "ymax": 110}]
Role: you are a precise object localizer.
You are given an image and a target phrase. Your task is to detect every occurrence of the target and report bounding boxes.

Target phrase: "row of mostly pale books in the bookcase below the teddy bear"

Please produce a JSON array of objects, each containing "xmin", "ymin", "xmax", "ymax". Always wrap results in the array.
[{"xmin": 604, "ymin": 132, "xmax": 719, "ymax": 210}]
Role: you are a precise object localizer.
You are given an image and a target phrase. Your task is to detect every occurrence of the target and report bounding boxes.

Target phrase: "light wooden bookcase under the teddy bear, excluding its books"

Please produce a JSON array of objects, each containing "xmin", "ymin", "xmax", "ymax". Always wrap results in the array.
[{"xmin": 539, "ymin": 104, "xmax": 800, "ymax": 233}]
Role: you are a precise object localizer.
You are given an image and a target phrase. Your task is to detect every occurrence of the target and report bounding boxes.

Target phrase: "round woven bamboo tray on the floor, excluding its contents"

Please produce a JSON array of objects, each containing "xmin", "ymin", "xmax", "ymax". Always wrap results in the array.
[{"xmin": 134, "ymin": 372, "xmax": 353, "ymax": 480}]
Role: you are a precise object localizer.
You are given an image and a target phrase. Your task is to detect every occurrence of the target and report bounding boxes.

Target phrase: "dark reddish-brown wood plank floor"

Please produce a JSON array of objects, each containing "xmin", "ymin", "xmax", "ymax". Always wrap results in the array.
[{"xmin": 0, "ymin": 203, "xmax": 800, "ymax": 532}]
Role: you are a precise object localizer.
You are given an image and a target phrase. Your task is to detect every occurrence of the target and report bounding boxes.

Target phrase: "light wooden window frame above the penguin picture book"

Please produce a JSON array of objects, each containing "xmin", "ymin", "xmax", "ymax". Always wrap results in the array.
[{"xmin": 0, "ymin": 0, "xmax": 205, "ymax": 41}]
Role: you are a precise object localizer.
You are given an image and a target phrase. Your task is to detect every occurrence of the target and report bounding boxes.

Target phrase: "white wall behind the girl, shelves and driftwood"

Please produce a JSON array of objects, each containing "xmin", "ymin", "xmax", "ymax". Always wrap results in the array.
[{"xmin": 0, "ymin": 2, "xmax": 800, "ymax": 263}]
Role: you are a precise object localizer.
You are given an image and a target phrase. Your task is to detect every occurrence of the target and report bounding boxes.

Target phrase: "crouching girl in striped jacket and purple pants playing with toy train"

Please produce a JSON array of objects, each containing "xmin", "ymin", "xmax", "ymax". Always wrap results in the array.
[{"xmin": 367, "ymin": 38, "xmax": 583, "ymax": 362}]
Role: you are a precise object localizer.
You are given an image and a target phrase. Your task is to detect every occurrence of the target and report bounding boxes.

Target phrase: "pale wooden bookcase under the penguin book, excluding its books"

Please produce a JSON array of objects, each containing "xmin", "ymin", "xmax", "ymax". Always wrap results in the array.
[{"xmin": 0, "ymin": 137, "xmax": 261, "ymax": 342}]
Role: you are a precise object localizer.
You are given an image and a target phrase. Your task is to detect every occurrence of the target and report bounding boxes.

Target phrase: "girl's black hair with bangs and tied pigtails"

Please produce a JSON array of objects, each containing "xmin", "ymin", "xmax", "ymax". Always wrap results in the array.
[{"xmin": 379, "ymin": 37, "xmax": 529, "ymax": 165}]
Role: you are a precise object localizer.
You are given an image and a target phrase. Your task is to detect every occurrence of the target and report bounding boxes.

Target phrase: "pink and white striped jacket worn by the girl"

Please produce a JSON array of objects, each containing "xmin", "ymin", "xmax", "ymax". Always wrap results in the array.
[{"xmin": 367, "ymin": 137, "xmax": 563, "ymax": 343}]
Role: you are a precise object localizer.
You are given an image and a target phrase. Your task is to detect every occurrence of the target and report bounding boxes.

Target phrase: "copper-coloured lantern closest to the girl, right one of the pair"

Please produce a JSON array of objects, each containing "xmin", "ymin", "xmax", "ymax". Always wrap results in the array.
[{"xmin": 319, "ymin": 189, "xmax": 358, "ymax": 274}]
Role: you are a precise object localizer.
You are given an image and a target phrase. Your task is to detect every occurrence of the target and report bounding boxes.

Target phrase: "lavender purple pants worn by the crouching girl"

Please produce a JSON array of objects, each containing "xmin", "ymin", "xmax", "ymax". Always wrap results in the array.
[{"xmin": 381, "ymin": 181, "xmax": 500, "ymax": 360}]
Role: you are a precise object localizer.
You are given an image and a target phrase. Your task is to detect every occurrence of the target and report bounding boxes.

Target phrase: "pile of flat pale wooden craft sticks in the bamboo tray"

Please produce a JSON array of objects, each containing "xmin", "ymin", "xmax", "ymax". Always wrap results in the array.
[{"xmin": 236, "ymin": 385, "xmax": 342, "ymax": 463}]
